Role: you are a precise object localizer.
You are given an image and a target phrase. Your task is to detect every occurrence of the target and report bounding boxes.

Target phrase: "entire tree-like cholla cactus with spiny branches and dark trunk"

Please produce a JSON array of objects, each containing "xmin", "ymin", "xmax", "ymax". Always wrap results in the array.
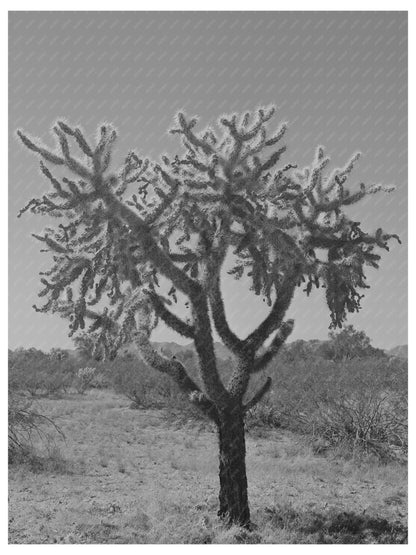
[{"xmin": 18, "ymin": 108, "xmax": 397, "ymax": 524}]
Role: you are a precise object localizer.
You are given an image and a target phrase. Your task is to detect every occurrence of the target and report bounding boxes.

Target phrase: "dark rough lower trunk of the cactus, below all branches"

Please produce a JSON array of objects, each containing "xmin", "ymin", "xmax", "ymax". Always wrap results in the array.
[{"xmin": 218, "ymin": 406, "xmax": 250, "ymax": 526}]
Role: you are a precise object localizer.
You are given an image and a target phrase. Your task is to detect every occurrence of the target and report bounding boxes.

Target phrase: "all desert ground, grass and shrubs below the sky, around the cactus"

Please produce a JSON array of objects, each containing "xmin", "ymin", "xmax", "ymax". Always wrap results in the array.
[{"xmin": 9, "ymin": 330, "xmax": 407, "ymax": 543}]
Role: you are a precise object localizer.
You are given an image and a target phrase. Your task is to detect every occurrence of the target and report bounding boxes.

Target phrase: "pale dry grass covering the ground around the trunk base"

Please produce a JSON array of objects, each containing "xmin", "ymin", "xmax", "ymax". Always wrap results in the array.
[{"xmin": 9, "ymin": 391, "xmax": 407, "ymax": 543}]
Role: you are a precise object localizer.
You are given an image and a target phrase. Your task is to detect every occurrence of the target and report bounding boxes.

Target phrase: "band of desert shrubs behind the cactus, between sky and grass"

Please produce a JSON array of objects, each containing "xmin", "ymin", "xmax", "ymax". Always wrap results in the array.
[{"xmin": 9, "ymin": 327, "xmax": 408, "ymax": 462}]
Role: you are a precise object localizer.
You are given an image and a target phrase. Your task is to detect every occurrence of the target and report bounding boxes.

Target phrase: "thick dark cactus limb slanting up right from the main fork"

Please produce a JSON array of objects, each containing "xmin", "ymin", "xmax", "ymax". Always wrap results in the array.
[{"xmin": 244, "ymin": 271, "xmax": 298, "ymax": 351}]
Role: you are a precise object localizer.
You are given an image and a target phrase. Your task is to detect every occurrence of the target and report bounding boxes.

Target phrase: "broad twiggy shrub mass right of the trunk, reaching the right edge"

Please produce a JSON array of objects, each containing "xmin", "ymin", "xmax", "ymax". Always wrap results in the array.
[{"xmin": 262, "ymin": 356, "xmax": 407, "ymax": 459}]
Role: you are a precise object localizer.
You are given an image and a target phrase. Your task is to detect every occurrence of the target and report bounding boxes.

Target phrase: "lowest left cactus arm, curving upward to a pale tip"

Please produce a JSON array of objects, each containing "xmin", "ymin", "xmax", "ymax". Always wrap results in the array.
[{"xmin": 135, "ymin": 311, "xmax": 217, "ymax": 418}]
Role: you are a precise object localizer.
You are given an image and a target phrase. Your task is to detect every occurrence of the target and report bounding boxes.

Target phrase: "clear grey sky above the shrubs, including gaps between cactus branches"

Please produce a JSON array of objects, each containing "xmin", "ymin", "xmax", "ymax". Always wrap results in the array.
[{"xmin": 9, "ymin": 12, "xmax": 407, "ymax": 350}]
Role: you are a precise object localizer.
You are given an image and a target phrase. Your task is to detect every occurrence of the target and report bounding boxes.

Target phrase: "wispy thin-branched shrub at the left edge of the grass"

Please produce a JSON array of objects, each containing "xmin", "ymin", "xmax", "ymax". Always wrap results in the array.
[{"xmin": 8, "ymin": 391, "xmax": 64, "ymax": 463}]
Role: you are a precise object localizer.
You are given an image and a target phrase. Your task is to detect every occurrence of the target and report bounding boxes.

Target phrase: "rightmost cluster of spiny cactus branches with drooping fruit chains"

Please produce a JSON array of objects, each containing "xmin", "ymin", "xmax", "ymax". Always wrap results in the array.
[{"xmin": 282, "ymin": 147, "xmax": 400, "ymax": 328}]
